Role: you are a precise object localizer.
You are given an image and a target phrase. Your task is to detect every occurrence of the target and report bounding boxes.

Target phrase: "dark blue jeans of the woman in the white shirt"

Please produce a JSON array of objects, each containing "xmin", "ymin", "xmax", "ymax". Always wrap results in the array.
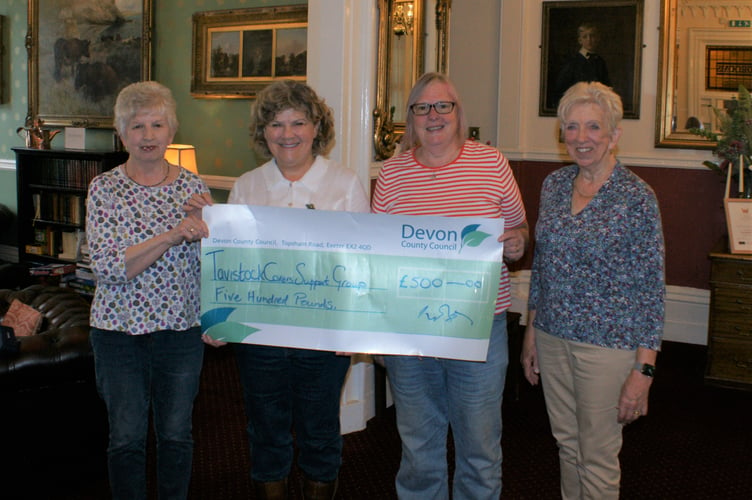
[{"xmin": 234, "ymin": 344, "xmax": 350, "ymax": 482}]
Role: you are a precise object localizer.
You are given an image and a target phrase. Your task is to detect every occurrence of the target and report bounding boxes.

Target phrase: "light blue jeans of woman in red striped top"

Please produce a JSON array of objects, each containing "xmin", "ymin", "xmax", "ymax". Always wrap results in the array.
[{"xmin": 385, "ymin": 313, "xmax": 509, "ymax": 500}]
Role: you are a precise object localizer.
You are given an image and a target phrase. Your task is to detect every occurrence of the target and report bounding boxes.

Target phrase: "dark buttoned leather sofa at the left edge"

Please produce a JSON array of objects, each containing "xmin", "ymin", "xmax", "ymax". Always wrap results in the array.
[{"xmin": 0, "ymin": 285, "xmax": 107, "ymax": 498}]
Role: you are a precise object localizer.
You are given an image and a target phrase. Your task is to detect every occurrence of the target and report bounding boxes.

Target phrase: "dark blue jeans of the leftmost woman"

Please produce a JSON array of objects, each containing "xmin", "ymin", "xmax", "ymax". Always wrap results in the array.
[{"xmin": 91, "ymin": 327, "xmax": 204, "ymax": 500}]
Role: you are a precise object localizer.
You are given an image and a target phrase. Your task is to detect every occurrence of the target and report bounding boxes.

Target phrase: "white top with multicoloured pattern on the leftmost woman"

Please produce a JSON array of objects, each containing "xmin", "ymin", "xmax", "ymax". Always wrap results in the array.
[{"xmin": 86, "ymin": 166, "xmax": 209, "ymax": 335}]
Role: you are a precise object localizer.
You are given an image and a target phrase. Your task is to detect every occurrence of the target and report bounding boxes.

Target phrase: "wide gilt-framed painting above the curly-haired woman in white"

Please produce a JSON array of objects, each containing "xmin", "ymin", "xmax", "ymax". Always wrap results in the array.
[{"xmin": 191, "ymin": 5, "xmax": 308, "ymax": 99}]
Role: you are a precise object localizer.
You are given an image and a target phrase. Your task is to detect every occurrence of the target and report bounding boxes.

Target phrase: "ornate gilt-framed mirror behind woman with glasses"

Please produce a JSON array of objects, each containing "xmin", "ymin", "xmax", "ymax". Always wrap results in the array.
[{"xmin": 373, "ymin": 0, "xmax": 451, "ymax": 160}]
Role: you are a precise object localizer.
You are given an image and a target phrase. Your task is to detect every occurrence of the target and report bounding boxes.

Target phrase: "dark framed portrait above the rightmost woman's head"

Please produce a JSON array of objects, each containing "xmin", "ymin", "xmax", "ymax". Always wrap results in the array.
[{"xmin": 538, "ymin": 0, "xmax": 643, "ymax": 119}]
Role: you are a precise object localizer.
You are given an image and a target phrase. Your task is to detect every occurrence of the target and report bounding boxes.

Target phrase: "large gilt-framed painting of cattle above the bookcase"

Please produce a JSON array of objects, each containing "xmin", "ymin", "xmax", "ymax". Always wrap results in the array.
[{"xmin": 26, "ymin": 0, "xmax": 152, "ymax": 128}]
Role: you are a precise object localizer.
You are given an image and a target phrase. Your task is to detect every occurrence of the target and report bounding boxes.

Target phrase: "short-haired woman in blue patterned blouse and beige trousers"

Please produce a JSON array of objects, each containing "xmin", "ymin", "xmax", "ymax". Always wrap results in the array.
[{"xmin": 521, "ymin": 82, "xmax": 665, "ymax": 499}]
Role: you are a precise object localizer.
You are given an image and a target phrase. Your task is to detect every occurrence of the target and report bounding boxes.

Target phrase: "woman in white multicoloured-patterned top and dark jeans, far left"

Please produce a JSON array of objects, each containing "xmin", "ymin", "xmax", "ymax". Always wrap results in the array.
[{"xmin": 86, "ymin": 82, "xmax": 210, "ymax": 499}]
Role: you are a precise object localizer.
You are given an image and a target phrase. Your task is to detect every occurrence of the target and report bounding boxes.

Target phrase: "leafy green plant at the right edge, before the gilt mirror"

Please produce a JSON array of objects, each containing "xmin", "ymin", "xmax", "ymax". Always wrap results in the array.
[{"xmin": 689, "ymin": 85, "xmax": 752, "ymax": 198}]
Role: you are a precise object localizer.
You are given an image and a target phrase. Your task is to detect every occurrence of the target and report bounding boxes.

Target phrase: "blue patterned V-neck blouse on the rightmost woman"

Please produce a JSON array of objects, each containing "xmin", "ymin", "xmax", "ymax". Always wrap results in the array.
[{"xmin": 528, "ymin": 163, "xmax": 665, "ymax": 350}]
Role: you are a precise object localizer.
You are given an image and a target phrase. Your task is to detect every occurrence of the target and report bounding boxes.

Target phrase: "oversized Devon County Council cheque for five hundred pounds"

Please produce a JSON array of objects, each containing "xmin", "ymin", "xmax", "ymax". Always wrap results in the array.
[{"xmin": 201, "ymin": 205, "xmax": 504, "ymax": 361}]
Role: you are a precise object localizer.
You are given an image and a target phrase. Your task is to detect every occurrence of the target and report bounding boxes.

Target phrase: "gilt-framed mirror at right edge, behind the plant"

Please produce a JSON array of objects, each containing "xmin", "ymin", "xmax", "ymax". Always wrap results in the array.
[{"xmin": 656, "ymin": 0, "xmax": 752, "ymax": 149}]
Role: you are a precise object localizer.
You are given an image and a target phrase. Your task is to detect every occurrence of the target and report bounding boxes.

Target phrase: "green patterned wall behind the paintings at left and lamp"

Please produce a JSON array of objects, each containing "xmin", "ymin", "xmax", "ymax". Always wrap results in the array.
[{"xmin": 0, "ymin": 0, "xmax": 307, "ymax": 216}]
